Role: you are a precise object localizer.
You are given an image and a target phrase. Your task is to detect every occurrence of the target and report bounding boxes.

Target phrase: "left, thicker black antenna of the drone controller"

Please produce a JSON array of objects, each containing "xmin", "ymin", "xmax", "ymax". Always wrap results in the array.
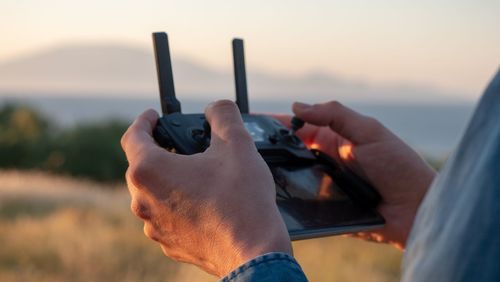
[{"xmin": 153, "ymin": 32, "xmax": 181, "ymax": 115}]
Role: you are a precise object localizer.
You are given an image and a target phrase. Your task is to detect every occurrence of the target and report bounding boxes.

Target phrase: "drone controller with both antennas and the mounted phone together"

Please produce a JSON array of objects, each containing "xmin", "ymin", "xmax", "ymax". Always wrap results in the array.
[{"xmin": 153, "ymin": 32, "xmax": 384, "ymax": 239}]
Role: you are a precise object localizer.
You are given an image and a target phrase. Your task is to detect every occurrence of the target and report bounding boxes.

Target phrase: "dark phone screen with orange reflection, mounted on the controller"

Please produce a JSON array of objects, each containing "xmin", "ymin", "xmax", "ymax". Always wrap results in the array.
[{"xmin": 272, "ymin": 165, "xmax": 380, "ymax": 232}]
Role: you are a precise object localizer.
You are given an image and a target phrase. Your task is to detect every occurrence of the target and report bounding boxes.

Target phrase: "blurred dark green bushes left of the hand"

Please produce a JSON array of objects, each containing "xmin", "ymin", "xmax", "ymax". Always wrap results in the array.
[{"xmin": 0, "ymin": 104, "xmax": 128, "ymax": 182}]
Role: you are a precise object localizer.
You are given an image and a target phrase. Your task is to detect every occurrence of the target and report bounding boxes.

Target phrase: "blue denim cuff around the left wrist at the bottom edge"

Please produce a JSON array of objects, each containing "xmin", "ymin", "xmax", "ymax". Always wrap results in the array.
[{"xmin": 221, "ymin": 253, "xmax": 307, "ymax": 282}]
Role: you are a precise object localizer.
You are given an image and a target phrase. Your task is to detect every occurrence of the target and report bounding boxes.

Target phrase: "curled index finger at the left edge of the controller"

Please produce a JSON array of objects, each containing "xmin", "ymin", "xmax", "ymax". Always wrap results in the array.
[{"xmin": 121, "ymin": 109, "xmax": 158, "ymax": 162}]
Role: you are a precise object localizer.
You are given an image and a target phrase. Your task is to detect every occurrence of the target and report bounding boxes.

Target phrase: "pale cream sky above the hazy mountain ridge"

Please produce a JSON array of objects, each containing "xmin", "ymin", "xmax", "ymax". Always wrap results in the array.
[{"xmin": 0, "ymin": 0, "xmax": 500, "ymax": 98}]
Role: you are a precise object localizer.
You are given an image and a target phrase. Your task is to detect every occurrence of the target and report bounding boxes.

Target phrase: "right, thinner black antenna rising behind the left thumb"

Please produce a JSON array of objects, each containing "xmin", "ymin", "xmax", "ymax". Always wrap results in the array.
[{"xmin": 233, "ymin": 38, "xmax": 249, "ymax": 114}]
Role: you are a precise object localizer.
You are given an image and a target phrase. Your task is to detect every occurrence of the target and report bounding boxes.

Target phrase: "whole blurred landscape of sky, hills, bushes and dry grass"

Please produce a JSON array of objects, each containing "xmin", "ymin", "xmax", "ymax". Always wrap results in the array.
[{"xmin": 0, "ymin": 0, "xmax": 500, "ymax": 281}]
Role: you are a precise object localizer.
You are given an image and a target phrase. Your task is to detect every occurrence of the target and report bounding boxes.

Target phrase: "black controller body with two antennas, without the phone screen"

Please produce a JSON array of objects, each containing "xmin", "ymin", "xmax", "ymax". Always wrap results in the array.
[{"xmin": 153, "ymin": 32, "xmax": 380, "ymax": 237}]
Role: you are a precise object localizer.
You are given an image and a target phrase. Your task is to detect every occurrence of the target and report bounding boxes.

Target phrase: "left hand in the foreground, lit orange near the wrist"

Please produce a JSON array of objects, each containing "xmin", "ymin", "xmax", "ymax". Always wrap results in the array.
[{"xmin": 122, "ymin": 101, "xmax": 292, "ymax": 277}]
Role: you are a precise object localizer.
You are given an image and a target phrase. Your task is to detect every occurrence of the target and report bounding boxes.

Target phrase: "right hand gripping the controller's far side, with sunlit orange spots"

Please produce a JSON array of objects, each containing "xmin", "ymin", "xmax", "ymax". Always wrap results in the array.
[{"xmin": 275, "ymin": 102, "xmax": 435, "ymax": 248}]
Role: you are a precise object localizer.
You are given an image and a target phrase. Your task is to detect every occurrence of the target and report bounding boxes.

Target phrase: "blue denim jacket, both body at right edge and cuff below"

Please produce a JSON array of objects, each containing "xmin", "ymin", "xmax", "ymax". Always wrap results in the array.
[{"xmin": 222, "ymin": 71, "xmax": 500, "ymax": 282}]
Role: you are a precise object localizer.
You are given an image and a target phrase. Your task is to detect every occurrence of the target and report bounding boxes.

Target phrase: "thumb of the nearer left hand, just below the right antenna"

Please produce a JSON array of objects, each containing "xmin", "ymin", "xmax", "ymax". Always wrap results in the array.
[{"xmin": 205, "ymin": 100, "xmax": 255, "ymax": 147}]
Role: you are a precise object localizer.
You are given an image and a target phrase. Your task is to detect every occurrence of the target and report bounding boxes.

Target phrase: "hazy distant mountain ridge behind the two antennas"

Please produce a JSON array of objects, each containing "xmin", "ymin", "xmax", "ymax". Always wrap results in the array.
[{"xmin": 0, "ymin": 44, "xmax": 462, "ymax": 102}]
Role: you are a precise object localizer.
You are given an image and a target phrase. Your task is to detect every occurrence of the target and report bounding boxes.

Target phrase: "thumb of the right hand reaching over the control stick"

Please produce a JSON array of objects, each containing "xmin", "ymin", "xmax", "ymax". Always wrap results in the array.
[{"xmin": 292, "ymin": 101, "xmax": 388, "ymax": 144}]
